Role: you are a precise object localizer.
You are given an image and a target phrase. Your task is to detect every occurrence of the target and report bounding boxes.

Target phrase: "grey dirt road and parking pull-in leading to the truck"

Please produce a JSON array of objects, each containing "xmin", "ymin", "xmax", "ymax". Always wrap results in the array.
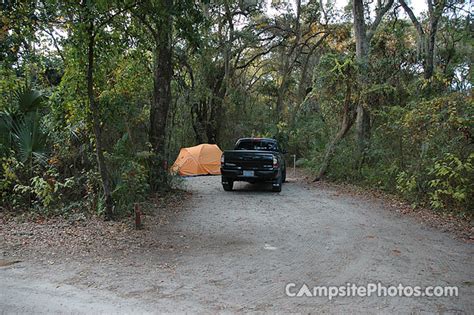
[{"xmin": 0, "ymin": 177, "xmax": 474, "ymax": 314}]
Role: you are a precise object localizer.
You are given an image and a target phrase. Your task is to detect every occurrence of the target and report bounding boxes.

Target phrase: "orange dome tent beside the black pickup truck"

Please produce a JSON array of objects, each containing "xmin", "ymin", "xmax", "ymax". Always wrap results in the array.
[{"xmin": 171, "ymin": 143, "xmax": 222, "ymax": 176}]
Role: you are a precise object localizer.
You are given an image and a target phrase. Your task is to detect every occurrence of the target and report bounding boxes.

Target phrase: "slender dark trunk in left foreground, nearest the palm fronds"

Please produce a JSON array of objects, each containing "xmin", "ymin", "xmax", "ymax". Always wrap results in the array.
[{"xmin": 87, "ymin": 22, "xmax": 114, "ymax": 219}]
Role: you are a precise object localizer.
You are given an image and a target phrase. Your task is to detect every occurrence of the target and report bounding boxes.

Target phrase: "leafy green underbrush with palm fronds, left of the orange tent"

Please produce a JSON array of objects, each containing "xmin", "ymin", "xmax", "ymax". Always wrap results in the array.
[{"xmin": 0, "ymin": 83, "xmax": 183, "ymax": 219}]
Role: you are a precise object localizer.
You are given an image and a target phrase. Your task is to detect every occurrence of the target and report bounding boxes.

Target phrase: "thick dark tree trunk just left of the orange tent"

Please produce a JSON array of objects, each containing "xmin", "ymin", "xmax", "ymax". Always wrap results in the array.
[{"xmin": 149, "ymin": 0, "xmax": 173, "ymax": 190}]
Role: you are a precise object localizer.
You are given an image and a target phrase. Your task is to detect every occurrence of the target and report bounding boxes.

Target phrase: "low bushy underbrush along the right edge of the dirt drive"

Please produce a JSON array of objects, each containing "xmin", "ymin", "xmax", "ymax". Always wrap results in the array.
[{"xmin": 300, "ymin": 93, "xmax": 474, "ymax": 218}]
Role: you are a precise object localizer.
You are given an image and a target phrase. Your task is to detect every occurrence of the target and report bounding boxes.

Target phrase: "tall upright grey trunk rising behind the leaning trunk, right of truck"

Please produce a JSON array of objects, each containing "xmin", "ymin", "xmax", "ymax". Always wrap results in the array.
[{"xmin": 352, "ymin": 0, "xmax": 370, "ymax": 160}]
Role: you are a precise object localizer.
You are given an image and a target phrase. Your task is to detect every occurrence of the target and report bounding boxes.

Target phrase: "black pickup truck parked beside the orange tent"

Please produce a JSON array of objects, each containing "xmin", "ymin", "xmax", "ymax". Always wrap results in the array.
[{"xmin": 221, "ymin": 138, "xmax": 286, "ymax": 192}]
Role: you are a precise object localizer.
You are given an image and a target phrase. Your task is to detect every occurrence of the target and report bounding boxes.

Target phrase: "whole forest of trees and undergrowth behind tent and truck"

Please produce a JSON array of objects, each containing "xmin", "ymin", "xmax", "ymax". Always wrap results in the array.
[{"xmin": 0, "ymin": 0, "xmax": 474, "ymax": 218}]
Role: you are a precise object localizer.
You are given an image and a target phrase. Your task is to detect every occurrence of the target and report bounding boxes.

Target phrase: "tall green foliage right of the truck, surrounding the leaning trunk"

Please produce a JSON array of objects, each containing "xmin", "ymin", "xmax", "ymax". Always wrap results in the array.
[{"xmin": 291, "ymin": 18, "xmax": 474, "ymax": 215}]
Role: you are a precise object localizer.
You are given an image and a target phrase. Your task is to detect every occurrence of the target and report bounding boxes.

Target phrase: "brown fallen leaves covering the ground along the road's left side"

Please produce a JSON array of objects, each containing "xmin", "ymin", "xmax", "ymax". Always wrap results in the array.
[{"xmin": 0, "ymin": 192, "xmax": 191, "ymax": 264}]
